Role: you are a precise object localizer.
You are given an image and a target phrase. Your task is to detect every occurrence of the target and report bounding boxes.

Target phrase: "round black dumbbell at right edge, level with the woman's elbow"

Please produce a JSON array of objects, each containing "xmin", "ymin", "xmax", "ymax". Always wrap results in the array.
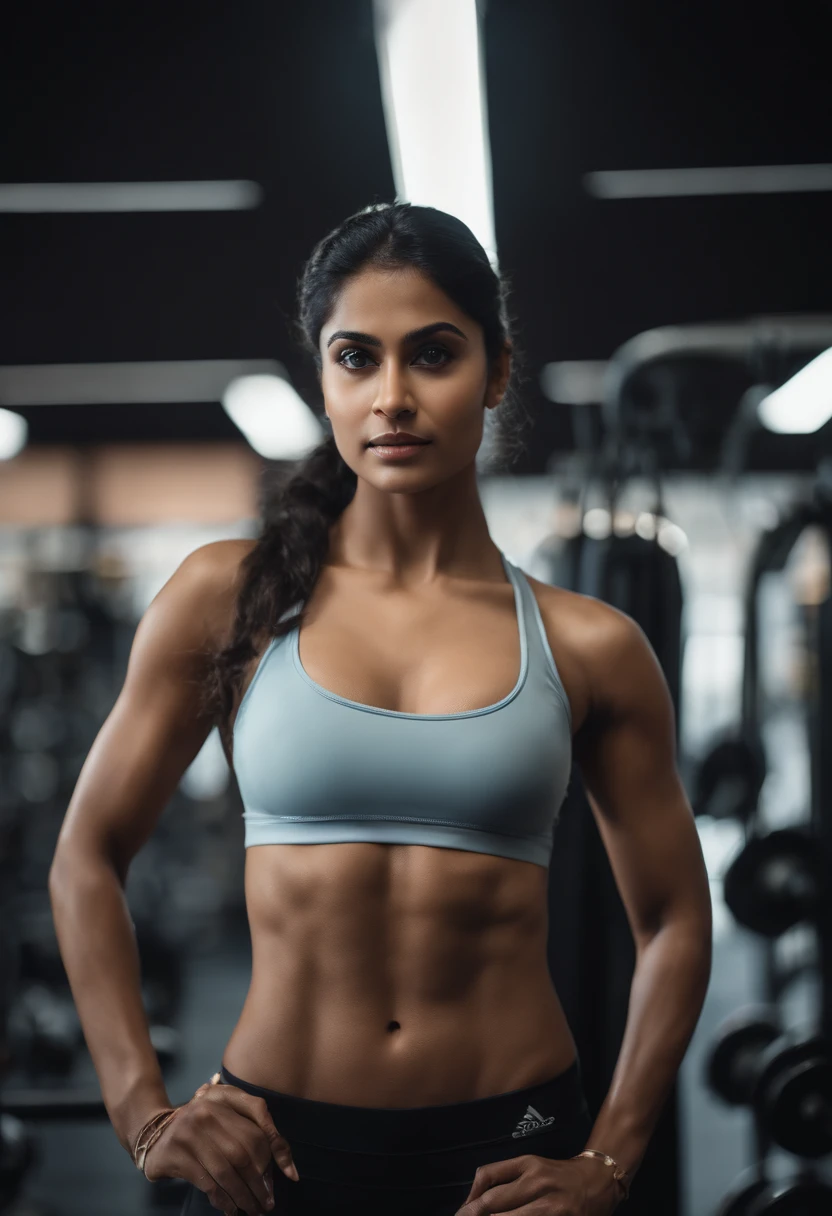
[{"xmin": 723, "ymin": 827, "xmax": 826, "ymax": 938}]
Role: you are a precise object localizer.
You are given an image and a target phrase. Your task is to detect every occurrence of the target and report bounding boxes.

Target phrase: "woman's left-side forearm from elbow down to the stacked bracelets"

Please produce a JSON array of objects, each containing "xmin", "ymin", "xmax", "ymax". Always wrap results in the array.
[{"xmin": 49, "ymin": 851, "xmax": 170, "ymax": 1149}]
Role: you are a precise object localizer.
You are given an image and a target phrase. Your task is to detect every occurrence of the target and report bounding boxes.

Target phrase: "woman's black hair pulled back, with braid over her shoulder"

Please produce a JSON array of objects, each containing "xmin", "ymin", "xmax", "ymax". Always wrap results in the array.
[{"xmin": 206, "ymin": 203, "xmax": 528, "ymax": 750}]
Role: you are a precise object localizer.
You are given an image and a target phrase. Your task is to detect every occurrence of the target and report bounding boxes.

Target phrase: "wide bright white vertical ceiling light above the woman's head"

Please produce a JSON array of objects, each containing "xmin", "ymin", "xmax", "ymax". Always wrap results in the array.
[{"xmin": 373, "ymin": 0, "xmax": 496, "ymax": 266}]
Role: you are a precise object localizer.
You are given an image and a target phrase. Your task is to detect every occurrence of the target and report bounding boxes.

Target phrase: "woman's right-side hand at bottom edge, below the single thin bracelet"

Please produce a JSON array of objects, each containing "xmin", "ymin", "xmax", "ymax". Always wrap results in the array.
[{"xmin": 456, "ymin": 1156, "xmax": 622, "ymax": 1216}]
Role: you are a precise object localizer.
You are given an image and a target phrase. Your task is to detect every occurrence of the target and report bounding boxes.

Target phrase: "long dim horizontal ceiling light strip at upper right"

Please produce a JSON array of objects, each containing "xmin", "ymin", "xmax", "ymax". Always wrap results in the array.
[{"xmin": 584, "ymin": 164, "xmax": 832, "ymax": 198}]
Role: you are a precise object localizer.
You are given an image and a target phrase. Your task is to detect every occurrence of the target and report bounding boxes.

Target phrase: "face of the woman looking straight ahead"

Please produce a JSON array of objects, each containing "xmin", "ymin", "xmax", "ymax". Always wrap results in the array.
[{"xmin": 320, "ymin": 269, "xmax": 511, "ymax": 490}]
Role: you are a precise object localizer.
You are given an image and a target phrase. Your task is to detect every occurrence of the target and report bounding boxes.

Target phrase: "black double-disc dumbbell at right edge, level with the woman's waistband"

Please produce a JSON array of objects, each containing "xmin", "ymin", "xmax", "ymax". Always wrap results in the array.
[{"xmin": 705, "ymin": 1007, "xmax": 832, "ymax": 1158}]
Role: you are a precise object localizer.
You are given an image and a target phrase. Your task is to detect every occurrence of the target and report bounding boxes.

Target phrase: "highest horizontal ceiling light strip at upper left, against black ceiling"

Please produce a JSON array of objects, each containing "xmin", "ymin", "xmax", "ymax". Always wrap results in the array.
[{"xmin": 0, "ymin": 181, "xmax": 263, "ymax": 214}]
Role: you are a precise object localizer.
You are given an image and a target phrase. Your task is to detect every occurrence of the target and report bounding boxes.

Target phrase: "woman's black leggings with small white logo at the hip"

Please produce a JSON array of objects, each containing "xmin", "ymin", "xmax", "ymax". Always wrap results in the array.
[{"xmin": 181, "ymin": 1060, "xmax": 592, "ymax": 1216}]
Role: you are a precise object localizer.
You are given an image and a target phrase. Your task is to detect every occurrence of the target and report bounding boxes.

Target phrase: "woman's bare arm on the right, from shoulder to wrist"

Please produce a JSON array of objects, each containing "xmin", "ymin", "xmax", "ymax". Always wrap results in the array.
[{"xmin": 575, "ymin": 601, "xmax": 712, "ymax": 1176}]
